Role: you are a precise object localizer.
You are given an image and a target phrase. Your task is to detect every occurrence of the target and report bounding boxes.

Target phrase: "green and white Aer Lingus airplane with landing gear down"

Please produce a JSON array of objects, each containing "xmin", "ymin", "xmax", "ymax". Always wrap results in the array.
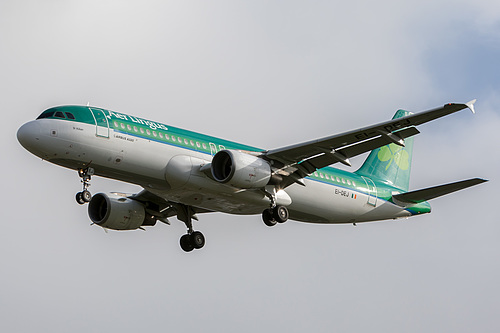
[{"xmin": 17, "ymin": 100, "xmax": 487, "ymax": 252}]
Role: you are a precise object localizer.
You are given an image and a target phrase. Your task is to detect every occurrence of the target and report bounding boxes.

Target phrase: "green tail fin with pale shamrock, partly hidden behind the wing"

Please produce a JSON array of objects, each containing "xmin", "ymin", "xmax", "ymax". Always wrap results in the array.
[{"xmin": 356, "ymin": 110, "xmax": 413, "ymax": 191}]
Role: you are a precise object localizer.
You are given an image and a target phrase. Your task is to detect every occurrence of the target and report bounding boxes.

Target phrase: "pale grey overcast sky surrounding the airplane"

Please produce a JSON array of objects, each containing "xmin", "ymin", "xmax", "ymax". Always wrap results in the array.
[{"xmin": 0, "ymin": 0, "xmax": 500, "ymax": 332}]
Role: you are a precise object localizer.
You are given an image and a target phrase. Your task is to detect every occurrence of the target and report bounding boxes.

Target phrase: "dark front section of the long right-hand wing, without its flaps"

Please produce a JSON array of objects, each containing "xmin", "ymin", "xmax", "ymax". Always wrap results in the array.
[{"xmin": 262, "ymin": 100, "xmax": 476, "ymax": 163}]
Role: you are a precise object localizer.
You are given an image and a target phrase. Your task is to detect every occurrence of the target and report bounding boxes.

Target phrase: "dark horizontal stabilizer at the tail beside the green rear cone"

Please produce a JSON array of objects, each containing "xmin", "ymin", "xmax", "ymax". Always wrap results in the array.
[{"xmin": 392, "ymin": 178, "xmax": 487, "ymax": 204}]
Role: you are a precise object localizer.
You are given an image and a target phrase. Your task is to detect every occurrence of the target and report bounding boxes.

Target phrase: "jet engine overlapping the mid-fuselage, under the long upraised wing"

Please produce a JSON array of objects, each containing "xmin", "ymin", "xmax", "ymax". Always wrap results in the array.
[{"xmin": 211, "ymin": 150, "xmax": 271, "ymax": 189}]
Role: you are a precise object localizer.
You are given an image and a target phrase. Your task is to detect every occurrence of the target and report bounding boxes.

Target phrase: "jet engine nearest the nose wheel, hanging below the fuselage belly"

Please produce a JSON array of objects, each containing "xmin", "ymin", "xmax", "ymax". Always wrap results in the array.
[{"xmin": 88, "ymin": 193, "xmax": 156, "ymax": 230}]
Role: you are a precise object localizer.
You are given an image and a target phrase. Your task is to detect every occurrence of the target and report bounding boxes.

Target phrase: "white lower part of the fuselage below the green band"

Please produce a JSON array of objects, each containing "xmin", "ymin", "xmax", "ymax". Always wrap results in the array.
[{"xmin": 19, "ymin": 119, "xmax": 412, "ymax": 223}]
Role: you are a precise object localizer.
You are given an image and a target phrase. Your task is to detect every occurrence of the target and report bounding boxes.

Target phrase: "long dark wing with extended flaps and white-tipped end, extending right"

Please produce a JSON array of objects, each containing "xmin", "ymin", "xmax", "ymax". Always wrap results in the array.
[{"xmin": 262, "ymin": 100, "xmax": 476, "ymax": 187}]
